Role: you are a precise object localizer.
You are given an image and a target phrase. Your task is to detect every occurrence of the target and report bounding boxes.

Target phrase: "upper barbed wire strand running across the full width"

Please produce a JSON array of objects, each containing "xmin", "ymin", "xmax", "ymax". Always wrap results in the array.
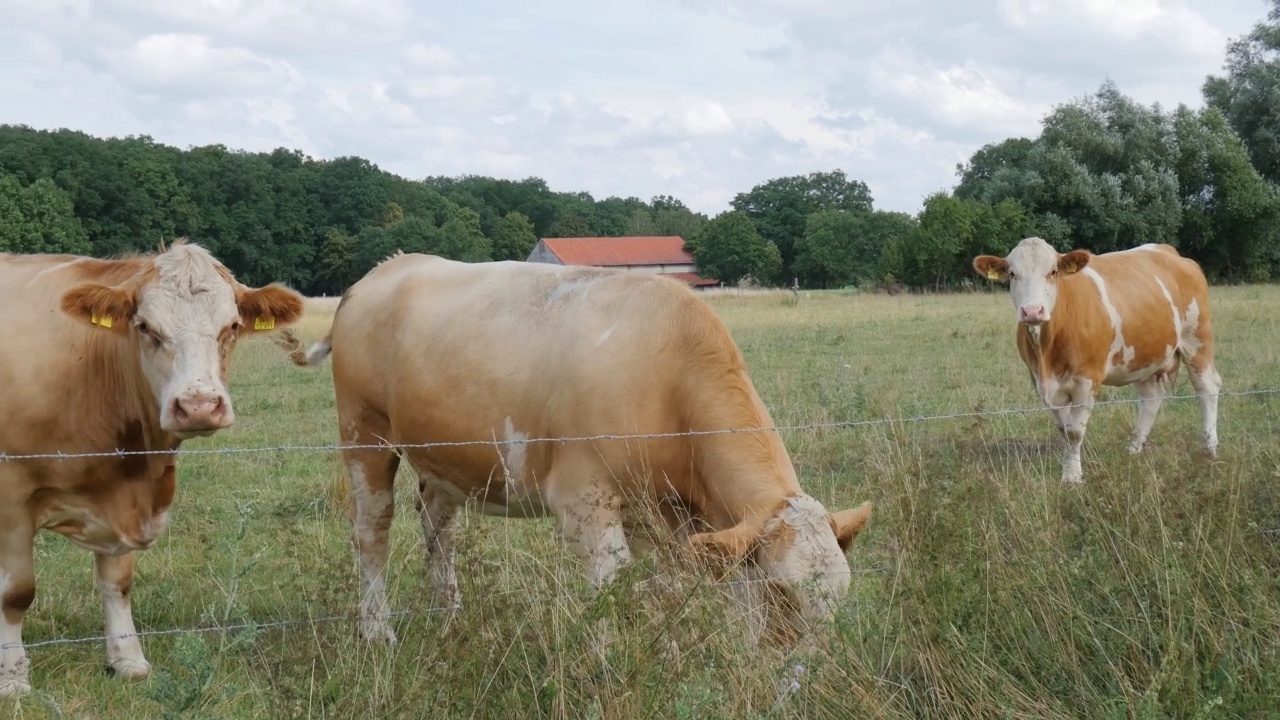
[{"xmin": 0, "ymin": 388, "xmax": 1280, "ymax": 462}]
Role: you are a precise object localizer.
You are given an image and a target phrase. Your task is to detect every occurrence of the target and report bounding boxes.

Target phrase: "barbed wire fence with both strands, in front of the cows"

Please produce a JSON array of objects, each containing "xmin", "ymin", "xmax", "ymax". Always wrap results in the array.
[{"xmin": 0, "ymin": 388, "xmax": 1280, "ymax": 651}]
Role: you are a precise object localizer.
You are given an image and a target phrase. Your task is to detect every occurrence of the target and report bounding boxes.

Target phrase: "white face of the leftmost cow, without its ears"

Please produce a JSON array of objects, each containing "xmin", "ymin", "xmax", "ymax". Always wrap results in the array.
[{"xmin": 133, "ymin": 245, "xmax": 239, "ymax": 438}]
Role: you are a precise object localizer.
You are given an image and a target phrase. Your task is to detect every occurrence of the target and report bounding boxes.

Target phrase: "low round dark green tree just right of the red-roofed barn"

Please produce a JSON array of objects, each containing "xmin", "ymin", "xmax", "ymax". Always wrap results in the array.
[{"xmin": 690, "ymin": 211, "xmax": 782, "ymax": 284}]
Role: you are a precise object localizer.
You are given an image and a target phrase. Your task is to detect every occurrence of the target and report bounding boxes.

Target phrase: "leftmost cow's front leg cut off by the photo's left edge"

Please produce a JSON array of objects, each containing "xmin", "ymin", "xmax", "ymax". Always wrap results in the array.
[{"xmin": 0, "ymin": 525, "xmax": 36, "ymax": 697}]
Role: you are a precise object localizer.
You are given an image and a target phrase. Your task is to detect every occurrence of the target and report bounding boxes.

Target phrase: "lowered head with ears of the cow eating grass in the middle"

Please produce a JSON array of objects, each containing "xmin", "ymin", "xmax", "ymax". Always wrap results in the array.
[{"xmin": 689, "ymin": 495, "xmax": 872, "ymax": 632}]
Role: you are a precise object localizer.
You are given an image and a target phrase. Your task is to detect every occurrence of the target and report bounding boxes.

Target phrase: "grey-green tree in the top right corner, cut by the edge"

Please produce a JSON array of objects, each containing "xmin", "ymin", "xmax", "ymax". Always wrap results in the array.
[{"xmin": 1201, "ymin": 0, "xmax": 1280, "ymax": 182}]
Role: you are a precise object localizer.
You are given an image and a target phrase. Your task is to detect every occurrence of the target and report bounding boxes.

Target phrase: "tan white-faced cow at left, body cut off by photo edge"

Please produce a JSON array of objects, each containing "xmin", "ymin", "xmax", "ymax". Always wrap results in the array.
[{"xmin": 0, "ymin": 240, "xmax": 302, "ymax": 696}]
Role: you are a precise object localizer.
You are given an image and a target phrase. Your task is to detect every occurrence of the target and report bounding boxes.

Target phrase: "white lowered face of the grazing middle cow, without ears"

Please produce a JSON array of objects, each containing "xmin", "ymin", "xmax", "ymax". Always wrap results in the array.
[{"xmin": 756, "ymin": 495, "xmax": 850, "ymax": 621}]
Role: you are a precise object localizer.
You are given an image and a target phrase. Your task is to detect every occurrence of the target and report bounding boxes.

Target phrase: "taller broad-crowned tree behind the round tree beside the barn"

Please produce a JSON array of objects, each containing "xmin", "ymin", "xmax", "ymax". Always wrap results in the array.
[{"xmin": 731, "ymin": 170, "xmax": 872, "ymax": 280}]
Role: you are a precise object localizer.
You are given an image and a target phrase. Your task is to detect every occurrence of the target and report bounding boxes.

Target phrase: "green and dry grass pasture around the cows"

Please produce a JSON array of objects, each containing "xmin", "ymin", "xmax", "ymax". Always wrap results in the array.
[{"xmin": 0, "ymin": 287, "xmax": 1280, "ymax": 720}]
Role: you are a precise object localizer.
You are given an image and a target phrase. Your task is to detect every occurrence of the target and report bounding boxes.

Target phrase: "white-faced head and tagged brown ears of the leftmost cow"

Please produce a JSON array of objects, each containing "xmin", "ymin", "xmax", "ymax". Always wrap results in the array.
[{"xmin": 61, "ymin": 241, "xmax": 303, "ymax": 438}]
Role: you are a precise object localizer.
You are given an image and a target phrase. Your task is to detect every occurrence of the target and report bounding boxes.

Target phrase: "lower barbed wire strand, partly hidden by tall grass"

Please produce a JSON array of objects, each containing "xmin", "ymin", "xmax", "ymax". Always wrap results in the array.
[{"xmin": 0, "ymin": 565, "xmax": 888, "ymax": 651}]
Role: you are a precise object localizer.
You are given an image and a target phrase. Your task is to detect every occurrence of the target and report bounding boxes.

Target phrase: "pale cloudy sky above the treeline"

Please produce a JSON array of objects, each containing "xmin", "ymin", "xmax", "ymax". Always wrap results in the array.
[{"xmin": 0, "ymin": 0, "xmax": 1270, "ymax": 215}]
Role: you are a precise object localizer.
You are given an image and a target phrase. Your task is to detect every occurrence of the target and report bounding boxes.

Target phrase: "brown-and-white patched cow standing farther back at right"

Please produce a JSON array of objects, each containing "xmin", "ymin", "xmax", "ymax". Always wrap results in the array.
[{"xmin": 973, "ymin": 237, "xmax": 1222, "ymax": 483}]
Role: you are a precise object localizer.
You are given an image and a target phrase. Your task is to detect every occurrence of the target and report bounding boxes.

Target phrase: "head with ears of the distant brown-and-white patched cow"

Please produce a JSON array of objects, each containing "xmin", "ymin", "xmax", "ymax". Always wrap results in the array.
[{"xmin": 973, "ymin": 237, "xmax": 1089, "ymax": 325}]
